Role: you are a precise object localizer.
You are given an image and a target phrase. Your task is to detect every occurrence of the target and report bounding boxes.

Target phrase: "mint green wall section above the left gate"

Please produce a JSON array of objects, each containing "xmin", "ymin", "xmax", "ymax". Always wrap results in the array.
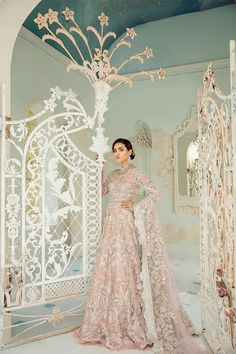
[{"xmin": 11, "ymin": 30, "xmax": 93, "ymax": 119}]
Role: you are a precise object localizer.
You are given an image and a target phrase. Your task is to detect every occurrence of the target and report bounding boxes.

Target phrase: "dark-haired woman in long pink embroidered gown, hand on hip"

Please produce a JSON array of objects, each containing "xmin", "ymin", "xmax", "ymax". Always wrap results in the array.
[{"xmin": 76, "ymin": 138, "xmax": 204, "ymax": 354}]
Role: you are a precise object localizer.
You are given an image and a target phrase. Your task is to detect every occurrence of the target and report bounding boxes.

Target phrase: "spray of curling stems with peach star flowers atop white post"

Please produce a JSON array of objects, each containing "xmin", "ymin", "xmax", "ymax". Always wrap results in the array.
[{"xmin": 34, "ymin": 7, "xmax": 165, "ymax": 89}]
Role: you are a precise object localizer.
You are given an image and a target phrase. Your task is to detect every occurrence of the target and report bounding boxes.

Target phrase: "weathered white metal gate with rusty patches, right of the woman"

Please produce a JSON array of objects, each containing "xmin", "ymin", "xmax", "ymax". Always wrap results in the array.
[{"xmin": 199, "ymin": 41, "xmax": 236, "ymax": 354}]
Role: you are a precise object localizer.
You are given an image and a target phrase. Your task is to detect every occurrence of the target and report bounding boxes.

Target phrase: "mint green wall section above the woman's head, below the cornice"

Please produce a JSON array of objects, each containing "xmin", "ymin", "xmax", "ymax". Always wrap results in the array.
[{"xmin": 105, "ymin": 66, "xmax": 229, "ymax": 138}]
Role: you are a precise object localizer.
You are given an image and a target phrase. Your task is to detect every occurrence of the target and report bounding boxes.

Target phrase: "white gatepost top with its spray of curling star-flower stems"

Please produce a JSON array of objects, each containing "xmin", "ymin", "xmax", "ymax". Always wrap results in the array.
[{"xmin": 34, "ymin": 7, "xmax": 166, "ymax": 163}]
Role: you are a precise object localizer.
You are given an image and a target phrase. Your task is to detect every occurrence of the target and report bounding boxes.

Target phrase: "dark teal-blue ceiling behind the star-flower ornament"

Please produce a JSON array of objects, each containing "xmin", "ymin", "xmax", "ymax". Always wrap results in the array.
[{"xmin": 24, "ymin": 0, "xmax": 235, "ymax": 64}]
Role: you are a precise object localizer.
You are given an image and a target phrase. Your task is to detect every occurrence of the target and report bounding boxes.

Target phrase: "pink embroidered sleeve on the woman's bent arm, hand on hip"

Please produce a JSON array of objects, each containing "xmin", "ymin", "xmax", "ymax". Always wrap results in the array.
[{"xmin": 136, "ymin": 171, "xmax": 161, "ymax": 209}]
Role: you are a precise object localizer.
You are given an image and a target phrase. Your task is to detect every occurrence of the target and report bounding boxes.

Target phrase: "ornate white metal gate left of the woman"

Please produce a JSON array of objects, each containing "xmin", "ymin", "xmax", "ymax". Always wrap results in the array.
[{"xmin": 0, "ymin": 87, "xmax": 101, "ymax": 348}]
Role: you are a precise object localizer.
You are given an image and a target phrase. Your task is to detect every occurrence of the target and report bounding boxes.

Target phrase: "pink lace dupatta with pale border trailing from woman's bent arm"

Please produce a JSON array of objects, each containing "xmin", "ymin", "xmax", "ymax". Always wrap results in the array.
[{"xmin": 134, "ymin": 170, "xmax": 206, "ymax": 354}]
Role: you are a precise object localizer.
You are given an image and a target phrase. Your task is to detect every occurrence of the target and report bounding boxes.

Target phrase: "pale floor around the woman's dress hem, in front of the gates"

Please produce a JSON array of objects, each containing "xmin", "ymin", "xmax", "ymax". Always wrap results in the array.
[{"xmin": 4, "ymin": 241, "xmax": 210, "ymax": 354}]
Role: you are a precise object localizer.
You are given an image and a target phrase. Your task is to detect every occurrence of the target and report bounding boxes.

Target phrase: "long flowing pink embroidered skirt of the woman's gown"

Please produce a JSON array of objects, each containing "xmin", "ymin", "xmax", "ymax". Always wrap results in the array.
[{"xmin": 76, "ymin": 208, "xmax": 152, "ymax": 350}]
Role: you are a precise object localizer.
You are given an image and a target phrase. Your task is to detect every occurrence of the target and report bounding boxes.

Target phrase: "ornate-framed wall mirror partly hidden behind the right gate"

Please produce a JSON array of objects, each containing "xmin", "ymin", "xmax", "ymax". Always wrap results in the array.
[{"xmin": 174, "ymin": 106, "xmax": 199, "ymax": 212}]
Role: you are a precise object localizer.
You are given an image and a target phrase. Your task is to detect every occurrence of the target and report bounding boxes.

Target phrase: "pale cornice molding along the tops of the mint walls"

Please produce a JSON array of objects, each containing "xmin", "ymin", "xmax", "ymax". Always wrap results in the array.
[{"xmin": 19, "ymin": 27, "xmax": 229, "ymax": 81}]
